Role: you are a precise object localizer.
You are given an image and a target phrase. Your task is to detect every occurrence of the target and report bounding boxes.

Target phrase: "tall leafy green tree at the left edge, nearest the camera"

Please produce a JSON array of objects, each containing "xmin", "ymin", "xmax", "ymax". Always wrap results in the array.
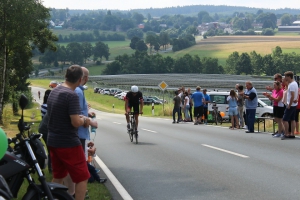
[{"xmin": 0, "ymin": 0, "xmax": 57, "ymax": 120}]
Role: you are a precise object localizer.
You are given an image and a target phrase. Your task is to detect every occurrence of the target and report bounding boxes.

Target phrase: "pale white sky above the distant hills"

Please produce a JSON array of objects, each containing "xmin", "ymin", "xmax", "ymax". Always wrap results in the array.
[{"xmin": 42, "ymin": 0, "xmax": 300, "ymax": 10}]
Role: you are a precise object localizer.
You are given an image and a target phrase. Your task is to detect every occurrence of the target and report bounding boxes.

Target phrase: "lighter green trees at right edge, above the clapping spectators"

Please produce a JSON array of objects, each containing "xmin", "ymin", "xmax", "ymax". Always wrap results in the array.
[{"xmin": 225, "ymin": 46, "xmax": 300, "ymax": 76}]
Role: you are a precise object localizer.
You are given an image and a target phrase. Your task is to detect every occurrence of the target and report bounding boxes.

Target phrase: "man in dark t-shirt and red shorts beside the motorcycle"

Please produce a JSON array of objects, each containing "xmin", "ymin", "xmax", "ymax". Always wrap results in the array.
[{"xmin": 47, "ymin": 65, "xmax": 91, "ymax": 200}]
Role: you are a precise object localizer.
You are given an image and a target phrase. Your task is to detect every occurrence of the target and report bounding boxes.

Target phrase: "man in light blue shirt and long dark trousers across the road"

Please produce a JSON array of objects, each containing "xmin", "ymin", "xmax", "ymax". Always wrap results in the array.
[{"xmin": 244, "ymin": 81, "xmax": 258, "ymax": 133}]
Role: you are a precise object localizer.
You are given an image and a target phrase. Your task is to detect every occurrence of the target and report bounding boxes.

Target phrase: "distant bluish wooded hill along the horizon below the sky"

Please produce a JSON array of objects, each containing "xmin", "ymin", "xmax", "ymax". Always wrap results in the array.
[{"xmin": 69, "ymin": 5, "xmax": 300, "ymax": 17}]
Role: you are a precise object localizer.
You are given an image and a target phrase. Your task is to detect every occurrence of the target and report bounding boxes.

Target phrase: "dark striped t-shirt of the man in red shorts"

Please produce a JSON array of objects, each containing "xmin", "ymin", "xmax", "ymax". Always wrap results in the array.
[{"xmin": 47, "ymin": 86, "xmax": 81, "ymax": 148}]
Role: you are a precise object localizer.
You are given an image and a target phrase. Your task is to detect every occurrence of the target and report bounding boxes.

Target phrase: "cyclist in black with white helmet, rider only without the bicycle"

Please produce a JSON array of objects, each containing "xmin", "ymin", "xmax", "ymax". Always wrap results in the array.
[{"xmin": 125, "ymin": 85, "xmax": 144, "ymax": 130}]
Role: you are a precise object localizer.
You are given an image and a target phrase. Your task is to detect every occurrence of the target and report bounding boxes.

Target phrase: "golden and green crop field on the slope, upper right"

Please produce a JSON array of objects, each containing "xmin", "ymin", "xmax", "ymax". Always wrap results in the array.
[{"xmin": 163, "ymin": 36, "xmax": 300, "ymax": 65}]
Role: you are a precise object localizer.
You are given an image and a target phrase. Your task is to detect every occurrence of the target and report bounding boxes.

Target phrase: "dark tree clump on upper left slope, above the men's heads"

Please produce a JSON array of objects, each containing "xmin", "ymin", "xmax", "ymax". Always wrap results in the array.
[{"xmin": 36, "ymin": 41, "xmax": 110, "ymax": 68}]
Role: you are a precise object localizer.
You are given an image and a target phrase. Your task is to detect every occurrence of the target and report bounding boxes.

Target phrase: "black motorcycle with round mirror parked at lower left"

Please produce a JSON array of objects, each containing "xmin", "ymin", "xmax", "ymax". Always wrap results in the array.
[{"xmin": 0, "ymin": 95, "xmax": 74, "ymax": 200}]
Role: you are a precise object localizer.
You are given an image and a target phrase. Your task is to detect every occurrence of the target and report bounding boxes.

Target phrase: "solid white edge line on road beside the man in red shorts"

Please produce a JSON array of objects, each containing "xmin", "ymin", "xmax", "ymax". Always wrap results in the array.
[{"xmin": 95, "ymin": 156, "xmax": 133, "ymax": 200}]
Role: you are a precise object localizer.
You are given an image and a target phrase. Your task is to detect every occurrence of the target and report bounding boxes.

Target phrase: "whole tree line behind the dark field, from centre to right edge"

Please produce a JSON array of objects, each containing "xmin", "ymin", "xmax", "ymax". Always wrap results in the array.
[{"xmin": 103, "ymin": 46, "xmax": 300, "ymax": 76}]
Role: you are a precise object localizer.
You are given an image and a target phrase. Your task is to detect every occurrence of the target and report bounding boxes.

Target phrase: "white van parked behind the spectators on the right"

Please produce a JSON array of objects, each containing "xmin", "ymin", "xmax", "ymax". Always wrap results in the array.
[{"xmin": 207, "ymin": 92, "xmax": 273, "ymax": 119}]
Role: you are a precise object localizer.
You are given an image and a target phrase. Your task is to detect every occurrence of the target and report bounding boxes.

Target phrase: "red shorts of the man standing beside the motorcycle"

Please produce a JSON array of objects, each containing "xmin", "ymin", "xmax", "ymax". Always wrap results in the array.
[{"xmin": 49, "ymin": 145, "xmax": 90, "ymax": 183}]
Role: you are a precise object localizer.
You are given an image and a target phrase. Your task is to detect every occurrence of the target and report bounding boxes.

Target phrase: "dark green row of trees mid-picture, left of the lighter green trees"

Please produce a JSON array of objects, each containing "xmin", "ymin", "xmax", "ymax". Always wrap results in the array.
[{"xmin": 103, "ymin": 51, "xmax": 224, "ymax": 75}]
